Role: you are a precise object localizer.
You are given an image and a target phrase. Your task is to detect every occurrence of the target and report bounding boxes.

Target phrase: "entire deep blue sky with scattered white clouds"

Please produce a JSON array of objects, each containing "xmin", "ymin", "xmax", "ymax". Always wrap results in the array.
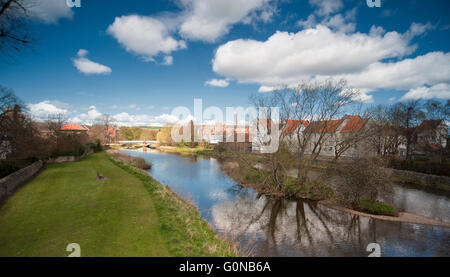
[{"xmin": 0, "ymin": 0, "xmax": 450, "ymax": 126}]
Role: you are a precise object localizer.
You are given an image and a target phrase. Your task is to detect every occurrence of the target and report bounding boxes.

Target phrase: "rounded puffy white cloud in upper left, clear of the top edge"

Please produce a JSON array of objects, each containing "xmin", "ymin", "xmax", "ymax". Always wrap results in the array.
[{"xmin": 107, "ymin": 15, "xmax": 186, "ymax": 62}]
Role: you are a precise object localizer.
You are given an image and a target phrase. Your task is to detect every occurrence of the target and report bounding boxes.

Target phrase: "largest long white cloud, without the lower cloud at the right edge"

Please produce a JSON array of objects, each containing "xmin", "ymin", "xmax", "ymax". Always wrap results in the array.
[{"xmin": 213, "ymin": 25, "xmax": 415, "ymax": 86}]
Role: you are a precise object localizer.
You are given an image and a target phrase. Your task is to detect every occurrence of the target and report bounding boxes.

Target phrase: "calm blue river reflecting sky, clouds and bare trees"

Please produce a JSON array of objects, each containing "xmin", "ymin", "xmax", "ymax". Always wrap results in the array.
[{"xmin": 123, "ymin": 150, "xmax": 450, "ymax": 256}]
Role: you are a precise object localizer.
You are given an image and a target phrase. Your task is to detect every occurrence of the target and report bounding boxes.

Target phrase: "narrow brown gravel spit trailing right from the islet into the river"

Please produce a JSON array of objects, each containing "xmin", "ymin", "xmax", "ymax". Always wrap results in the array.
[{"xmin": 319, "ymin": 202, "xmax": 450, "ymax": 228}]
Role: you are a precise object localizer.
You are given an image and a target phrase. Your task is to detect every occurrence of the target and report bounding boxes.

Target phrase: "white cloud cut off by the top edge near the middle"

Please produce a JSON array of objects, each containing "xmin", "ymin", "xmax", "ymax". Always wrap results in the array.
[{"xmin": 180, "ymin": 0, "xmax": 274, "ymax": 42}]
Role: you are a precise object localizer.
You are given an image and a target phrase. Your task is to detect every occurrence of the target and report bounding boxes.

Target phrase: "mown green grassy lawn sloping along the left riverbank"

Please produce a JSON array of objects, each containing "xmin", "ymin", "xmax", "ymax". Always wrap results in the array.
[{"xmin": 0, "ymin": 152, "xmax": 232, "ymax": 257}]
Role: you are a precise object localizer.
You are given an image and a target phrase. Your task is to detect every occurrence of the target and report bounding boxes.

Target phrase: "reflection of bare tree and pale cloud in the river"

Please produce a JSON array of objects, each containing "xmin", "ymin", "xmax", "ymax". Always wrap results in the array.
[{"xmin": 212, "ymin": 186, "xmax": 448, "ymax": 256}]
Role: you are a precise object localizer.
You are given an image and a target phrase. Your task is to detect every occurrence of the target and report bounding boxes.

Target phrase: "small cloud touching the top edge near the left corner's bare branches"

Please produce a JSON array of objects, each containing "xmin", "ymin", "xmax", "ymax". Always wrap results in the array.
[{"xmin": 22, "ymin": 0, "xmax": 73, "ymax": 23}]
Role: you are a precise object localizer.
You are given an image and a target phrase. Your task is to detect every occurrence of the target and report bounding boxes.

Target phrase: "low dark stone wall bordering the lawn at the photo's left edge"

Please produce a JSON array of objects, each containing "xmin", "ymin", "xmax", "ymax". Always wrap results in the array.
[{"xmin": 0, "ymin": 161, "xmax": 44, "ymax": 199}]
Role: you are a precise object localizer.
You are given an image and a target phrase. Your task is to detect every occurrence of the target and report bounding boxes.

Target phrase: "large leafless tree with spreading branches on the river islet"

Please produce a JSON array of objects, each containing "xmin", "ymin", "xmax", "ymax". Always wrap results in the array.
[{"xmin": 251, "ymin": 79, "xmax": 359, "ymax": 194}]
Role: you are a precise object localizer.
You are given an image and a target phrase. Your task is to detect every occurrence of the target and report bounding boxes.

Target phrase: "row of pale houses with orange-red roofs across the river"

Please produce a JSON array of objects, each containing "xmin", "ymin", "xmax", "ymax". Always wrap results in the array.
[{"xmin": 182, "ymin": 115, "xmax": 448, "ymax": 157}]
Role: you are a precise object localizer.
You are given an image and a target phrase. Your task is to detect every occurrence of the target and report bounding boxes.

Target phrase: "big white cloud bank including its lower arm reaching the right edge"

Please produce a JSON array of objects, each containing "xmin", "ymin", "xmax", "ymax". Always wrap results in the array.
[{"xmin": 213, "ymin": 23, "xmax": 450, "ymax": 102}]
